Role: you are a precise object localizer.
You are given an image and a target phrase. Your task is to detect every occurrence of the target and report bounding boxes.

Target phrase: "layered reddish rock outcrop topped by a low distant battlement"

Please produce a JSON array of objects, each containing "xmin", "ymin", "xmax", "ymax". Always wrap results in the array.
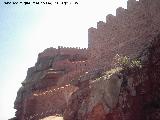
[{"xmin": 14, "ymin": 47, "xmax": 87, "ymax": 120}]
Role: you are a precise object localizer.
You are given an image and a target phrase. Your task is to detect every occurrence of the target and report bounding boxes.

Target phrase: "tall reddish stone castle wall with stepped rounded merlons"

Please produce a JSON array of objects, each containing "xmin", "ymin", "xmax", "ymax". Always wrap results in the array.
[{"xmin": 88, "ymin": 0, "xmax": 160, "ymax": 69}]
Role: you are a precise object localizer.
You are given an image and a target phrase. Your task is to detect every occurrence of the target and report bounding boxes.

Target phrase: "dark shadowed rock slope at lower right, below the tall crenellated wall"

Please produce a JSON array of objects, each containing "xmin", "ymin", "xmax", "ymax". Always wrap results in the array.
[{"xmin": 64, "ymin": 35, "xmax": 160, "ymax": 120}]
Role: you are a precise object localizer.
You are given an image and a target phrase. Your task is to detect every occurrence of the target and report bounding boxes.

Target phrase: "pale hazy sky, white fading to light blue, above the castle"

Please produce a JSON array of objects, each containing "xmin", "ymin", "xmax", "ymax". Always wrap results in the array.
[{"xmin": 0, "ymin": 0, "xmax": 127, "ymax": 120}]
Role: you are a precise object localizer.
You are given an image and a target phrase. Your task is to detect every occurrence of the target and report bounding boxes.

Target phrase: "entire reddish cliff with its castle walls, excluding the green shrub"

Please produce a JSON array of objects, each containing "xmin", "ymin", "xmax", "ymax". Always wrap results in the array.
[{"xmin": 14, "ymin": 0, "xmax": 160, "ymax": 120}]
